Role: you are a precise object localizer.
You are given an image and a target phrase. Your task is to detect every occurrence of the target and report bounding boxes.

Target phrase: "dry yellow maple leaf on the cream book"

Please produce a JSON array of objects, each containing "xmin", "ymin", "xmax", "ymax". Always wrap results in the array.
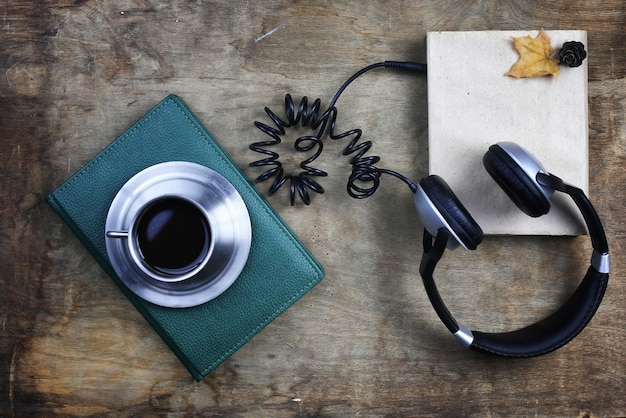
[{"xmin": 506, "ymin": 29, "xmax": 559, "ymax": 78}]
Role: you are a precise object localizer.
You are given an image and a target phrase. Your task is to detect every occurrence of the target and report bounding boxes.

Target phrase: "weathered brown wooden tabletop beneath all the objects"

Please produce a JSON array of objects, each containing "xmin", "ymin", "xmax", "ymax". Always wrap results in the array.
[{"xmin": 0, "ymin": 0, "xmax": 626, "ymax": 417}]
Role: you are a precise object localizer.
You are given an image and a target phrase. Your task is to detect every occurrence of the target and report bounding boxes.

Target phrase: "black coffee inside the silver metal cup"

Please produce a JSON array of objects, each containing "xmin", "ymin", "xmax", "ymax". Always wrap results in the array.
[{"xmin": 137, "ymin": 197, "xmax": 211, "ymax": 275}]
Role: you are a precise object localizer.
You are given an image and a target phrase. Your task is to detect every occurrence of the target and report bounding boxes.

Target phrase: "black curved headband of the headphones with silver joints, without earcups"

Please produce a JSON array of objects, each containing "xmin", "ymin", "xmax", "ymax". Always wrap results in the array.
[{"xmin": 420, "ymin": 172, "xmax": 610, "ymax": 357}]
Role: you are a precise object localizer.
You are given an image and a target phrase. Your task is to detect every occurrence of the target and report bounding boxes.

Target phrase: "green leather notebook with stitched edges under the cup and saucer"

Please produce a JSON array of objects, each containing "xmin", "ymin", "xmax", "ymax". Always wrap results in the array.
[{"xmin": 48, "ymin": 95, "xmax": 324, "ymax": 381}]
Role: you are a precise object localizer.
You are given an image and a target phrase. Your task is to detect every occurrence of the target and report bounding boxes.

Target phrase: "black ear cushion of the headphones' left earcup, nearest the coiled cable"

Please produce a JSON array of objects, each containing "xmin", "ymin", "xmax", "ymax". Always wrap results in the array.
[{"xmin": 420, "ymin": 175, "xmax": 483, "ymax": 250}]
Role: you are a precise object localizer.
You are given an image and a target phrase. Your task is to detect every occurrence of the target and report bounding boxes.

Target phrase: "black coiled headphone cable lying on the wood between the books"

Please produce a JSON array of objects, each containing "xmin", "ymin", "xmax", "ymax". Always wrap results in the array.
[{"xmin": 249, "ymin": 61, "xmax": 426, "ymax": 206}]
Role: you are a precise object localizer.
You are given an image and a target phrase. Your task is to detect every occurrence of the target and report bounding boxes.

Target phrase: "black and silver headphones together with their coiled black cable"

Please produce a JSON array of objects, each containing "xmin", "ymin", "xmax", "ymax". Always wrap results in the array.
[{"xmin": 250, "ymin": 61, "xmax": 610, "ymax": 357}]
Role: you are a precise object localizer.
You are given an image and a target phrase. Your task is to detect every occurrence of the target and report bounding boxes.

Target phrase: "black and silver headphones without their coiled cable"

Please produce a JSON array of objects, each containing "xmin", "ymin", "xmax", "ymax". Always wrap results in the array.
[{"xmin": 414, "ymin": 142, "xmax": 610, "ymax": 357}]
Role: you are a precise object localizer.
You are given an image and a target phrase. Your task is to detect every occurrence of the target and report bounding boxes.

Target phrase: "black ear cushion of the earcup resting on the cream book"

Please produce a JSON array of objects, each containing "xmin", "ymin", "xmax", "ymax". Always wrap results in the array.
[{"xmin": 483, "ymin": 144, "xmax": 550, "ymax": 218}]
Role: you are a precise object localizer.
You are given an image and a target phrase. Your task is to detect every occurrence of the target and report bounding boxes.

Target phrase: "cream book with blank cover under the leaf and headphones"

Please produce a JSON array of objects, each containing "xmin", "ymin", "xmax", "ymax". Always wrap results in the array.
[{"xmin": 427, "ymin": 30, "xmax": 593, "ymax": 235}]
